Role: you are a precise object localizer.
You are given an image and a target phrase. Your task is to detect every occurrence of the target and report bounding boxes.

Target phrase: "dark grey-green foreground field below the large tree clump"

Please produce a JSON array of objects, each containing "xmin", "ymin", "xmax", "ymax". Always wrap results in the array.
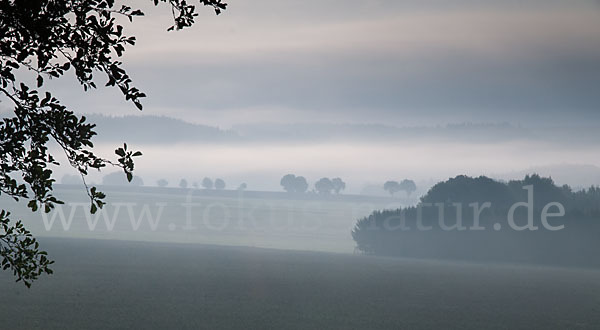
[{"xmin": 0, "ymin": 239, "xmax": 600, "ymax": 329}]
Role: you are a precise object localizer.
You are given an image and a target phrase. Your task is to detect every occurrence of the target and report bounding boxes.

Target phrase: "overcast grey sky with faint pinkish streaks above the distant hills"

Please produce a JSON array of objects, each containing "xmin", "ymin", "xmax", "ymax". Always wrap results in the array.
[{"xmin": 28, "ymin": 0, "xmax": 600, "ymax": 127}]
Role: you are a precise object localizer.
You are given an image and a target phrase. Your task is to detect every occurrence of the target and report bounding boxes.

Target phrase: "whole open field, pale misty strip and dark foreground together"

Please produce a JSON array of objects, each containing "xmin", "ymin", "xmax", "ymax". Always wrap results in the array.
[{"xmin": 0, "ymin": 187, "xmax": 600, "ymax": 329}]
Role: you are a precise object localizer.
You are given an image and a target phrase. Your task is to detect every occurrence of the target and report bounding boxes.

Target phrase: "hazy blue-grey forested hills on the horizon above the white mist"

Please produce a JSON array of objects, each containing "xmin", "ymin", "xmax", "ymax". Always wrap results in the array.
[{"xmin": 72, "ymin": 114, "xmax": 600, "ymax": 146}]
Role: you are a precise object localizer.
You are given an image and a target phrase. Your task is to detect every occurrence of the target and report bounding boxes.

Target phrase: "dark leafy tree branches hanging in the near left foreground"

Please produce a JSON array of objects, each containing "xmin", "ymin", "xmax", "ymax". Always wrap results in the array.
[{"xmin": 0, "ymin": 0, "xmax": 226, "ymax": 286}]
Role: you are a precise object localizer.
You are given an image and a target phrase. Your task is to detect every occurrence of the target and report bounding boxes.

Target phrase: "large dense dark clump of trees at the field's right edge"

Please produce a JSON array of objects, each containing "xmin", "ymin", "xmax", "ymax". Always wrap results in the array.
[{"xmin": 352, "ymin": 175, "xmax": 600, "ymax": 267}]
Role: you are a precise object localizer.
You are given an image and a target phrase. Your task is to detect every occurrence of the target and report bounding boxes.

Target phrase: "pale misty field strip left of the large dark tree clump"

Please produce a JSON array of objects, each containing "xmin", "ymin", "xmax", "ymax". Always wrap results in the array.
[{"xmin": 0, "ymin": 185, "xmax": 402, "ymax": 253}]
